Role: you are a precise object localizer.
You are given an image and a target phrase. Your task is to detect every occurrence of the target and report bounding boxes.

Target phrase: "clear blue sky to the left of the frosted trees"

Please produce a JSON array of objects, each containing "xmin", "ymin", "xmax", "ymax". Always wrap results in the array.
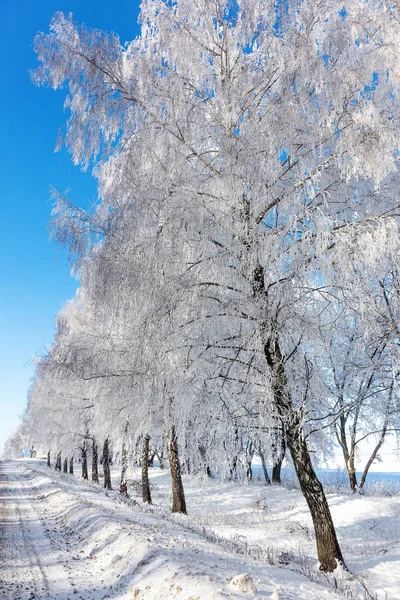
[{"xmin": 0, "ymin": 0, "xmax": 139, "ymax": 453}]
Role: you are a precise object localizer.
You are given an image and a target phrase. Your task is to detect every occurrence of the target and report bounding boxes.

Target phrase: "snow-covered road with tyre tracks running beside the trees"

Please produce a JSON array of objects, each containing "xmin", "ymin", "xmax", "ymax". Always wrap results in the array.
[{"xmin": 0, "ymin": 461, "xmax": 83, "ymax": 600}]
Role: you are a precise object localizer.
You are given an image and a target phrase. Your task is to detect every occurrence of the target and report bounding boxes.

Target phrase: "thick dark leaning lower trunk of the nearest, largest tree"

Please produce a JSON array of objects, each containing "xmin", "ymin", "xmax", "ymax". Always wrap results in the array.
[{"xmin": 264, "ymin": 338, "xmax": 345, "ymax": 572}]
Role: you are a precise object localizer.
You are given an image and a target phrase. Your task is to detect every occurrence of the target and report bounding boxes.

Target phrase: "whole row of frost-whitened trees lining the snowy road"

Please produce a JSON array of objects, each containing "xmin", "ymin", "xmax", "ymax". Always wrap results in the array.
[{"xmin": 8, "ymin": 0, "xmax": 400, "ymax": 571}]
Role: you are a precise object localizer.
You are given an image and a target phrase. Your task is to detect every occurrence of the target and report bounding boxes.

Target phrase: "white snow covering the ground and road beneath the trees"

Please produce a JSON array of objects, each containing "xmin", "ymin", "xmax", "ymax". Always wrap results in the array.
[{"xmin": 0, "ymin": 459, "xmax": 400, "ymax": 600}]
